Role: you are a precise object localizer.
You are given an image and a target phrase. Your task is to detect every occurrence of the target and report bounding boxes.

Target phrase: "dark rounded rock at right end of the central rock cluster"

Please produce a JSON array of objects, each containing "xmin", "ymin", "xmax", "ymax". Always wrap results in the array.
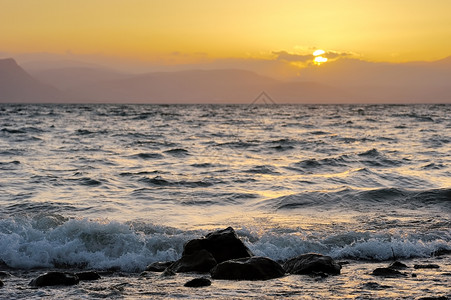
[{"xmin": 283, "ymin": 253, "xmax": 341, "ymax": 275}]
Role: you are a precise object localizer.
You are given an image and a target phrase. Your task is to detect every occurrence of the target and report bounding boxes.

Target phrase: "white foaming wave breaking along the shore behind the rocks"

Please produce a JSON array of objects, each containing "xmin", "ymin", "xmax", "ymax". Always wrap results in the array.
[{"xmin": 0, "ymin": 214, "xmax": 451, "ymax": 272}]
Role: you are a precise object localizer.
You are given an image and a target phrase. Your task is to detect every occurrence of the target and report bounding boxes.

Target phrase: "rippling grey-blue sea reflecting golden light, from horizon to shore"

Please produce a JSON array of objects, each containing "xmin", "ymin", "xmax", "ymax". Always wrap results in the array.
[{"xmin": 0, "ymin": 102, "xmax": 451, "ymax": 299}]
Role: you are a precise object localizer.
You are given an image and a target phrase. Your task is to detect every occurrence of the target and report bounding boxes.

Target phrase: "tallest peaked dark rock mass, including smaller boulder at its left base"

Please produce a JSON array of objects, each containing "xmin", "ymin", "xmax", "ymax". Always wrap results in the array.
[{"xmin": 168, "ymin": 227, "xmax": 253, "ymax": 272}]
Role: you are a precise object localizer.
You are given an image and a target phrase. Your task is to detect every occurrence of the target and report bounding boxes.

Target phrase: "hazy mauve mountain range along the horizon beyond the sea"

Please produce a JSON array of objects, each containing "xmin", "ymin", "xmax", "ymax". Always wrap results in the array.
[{"xmin": 0, "ymin": 57, "xmax": 451, "ymax": 103}]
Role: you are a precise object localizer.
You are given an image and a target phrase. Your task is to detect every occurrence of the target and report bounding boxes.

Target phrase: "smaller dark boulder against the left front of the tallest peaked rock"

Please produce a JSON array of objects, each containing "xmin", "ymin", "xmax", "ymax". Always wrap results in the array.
[{"xmin": 168, "ymin": 249, "xmax": 217, "ymax": 273}]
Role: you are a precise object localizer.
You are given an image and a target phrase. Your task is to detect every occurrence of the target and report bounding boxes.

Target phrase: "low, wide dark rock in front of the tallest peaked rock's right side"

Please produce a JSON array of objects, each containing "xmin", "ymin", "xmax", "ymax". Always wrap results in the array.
[{"xmin": 211, "ymin": 256, "xmax": 285, "ymax": 280}]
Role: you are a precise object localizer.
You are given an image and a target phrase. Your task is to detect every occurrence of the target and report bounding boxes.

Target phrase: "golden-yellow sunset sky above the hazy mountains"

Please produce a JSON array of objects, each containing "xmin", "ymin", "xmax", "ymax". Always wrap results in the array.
[{"xmin": 0, "ymin": 0, "xmax": 451, "ymax": 65}]
